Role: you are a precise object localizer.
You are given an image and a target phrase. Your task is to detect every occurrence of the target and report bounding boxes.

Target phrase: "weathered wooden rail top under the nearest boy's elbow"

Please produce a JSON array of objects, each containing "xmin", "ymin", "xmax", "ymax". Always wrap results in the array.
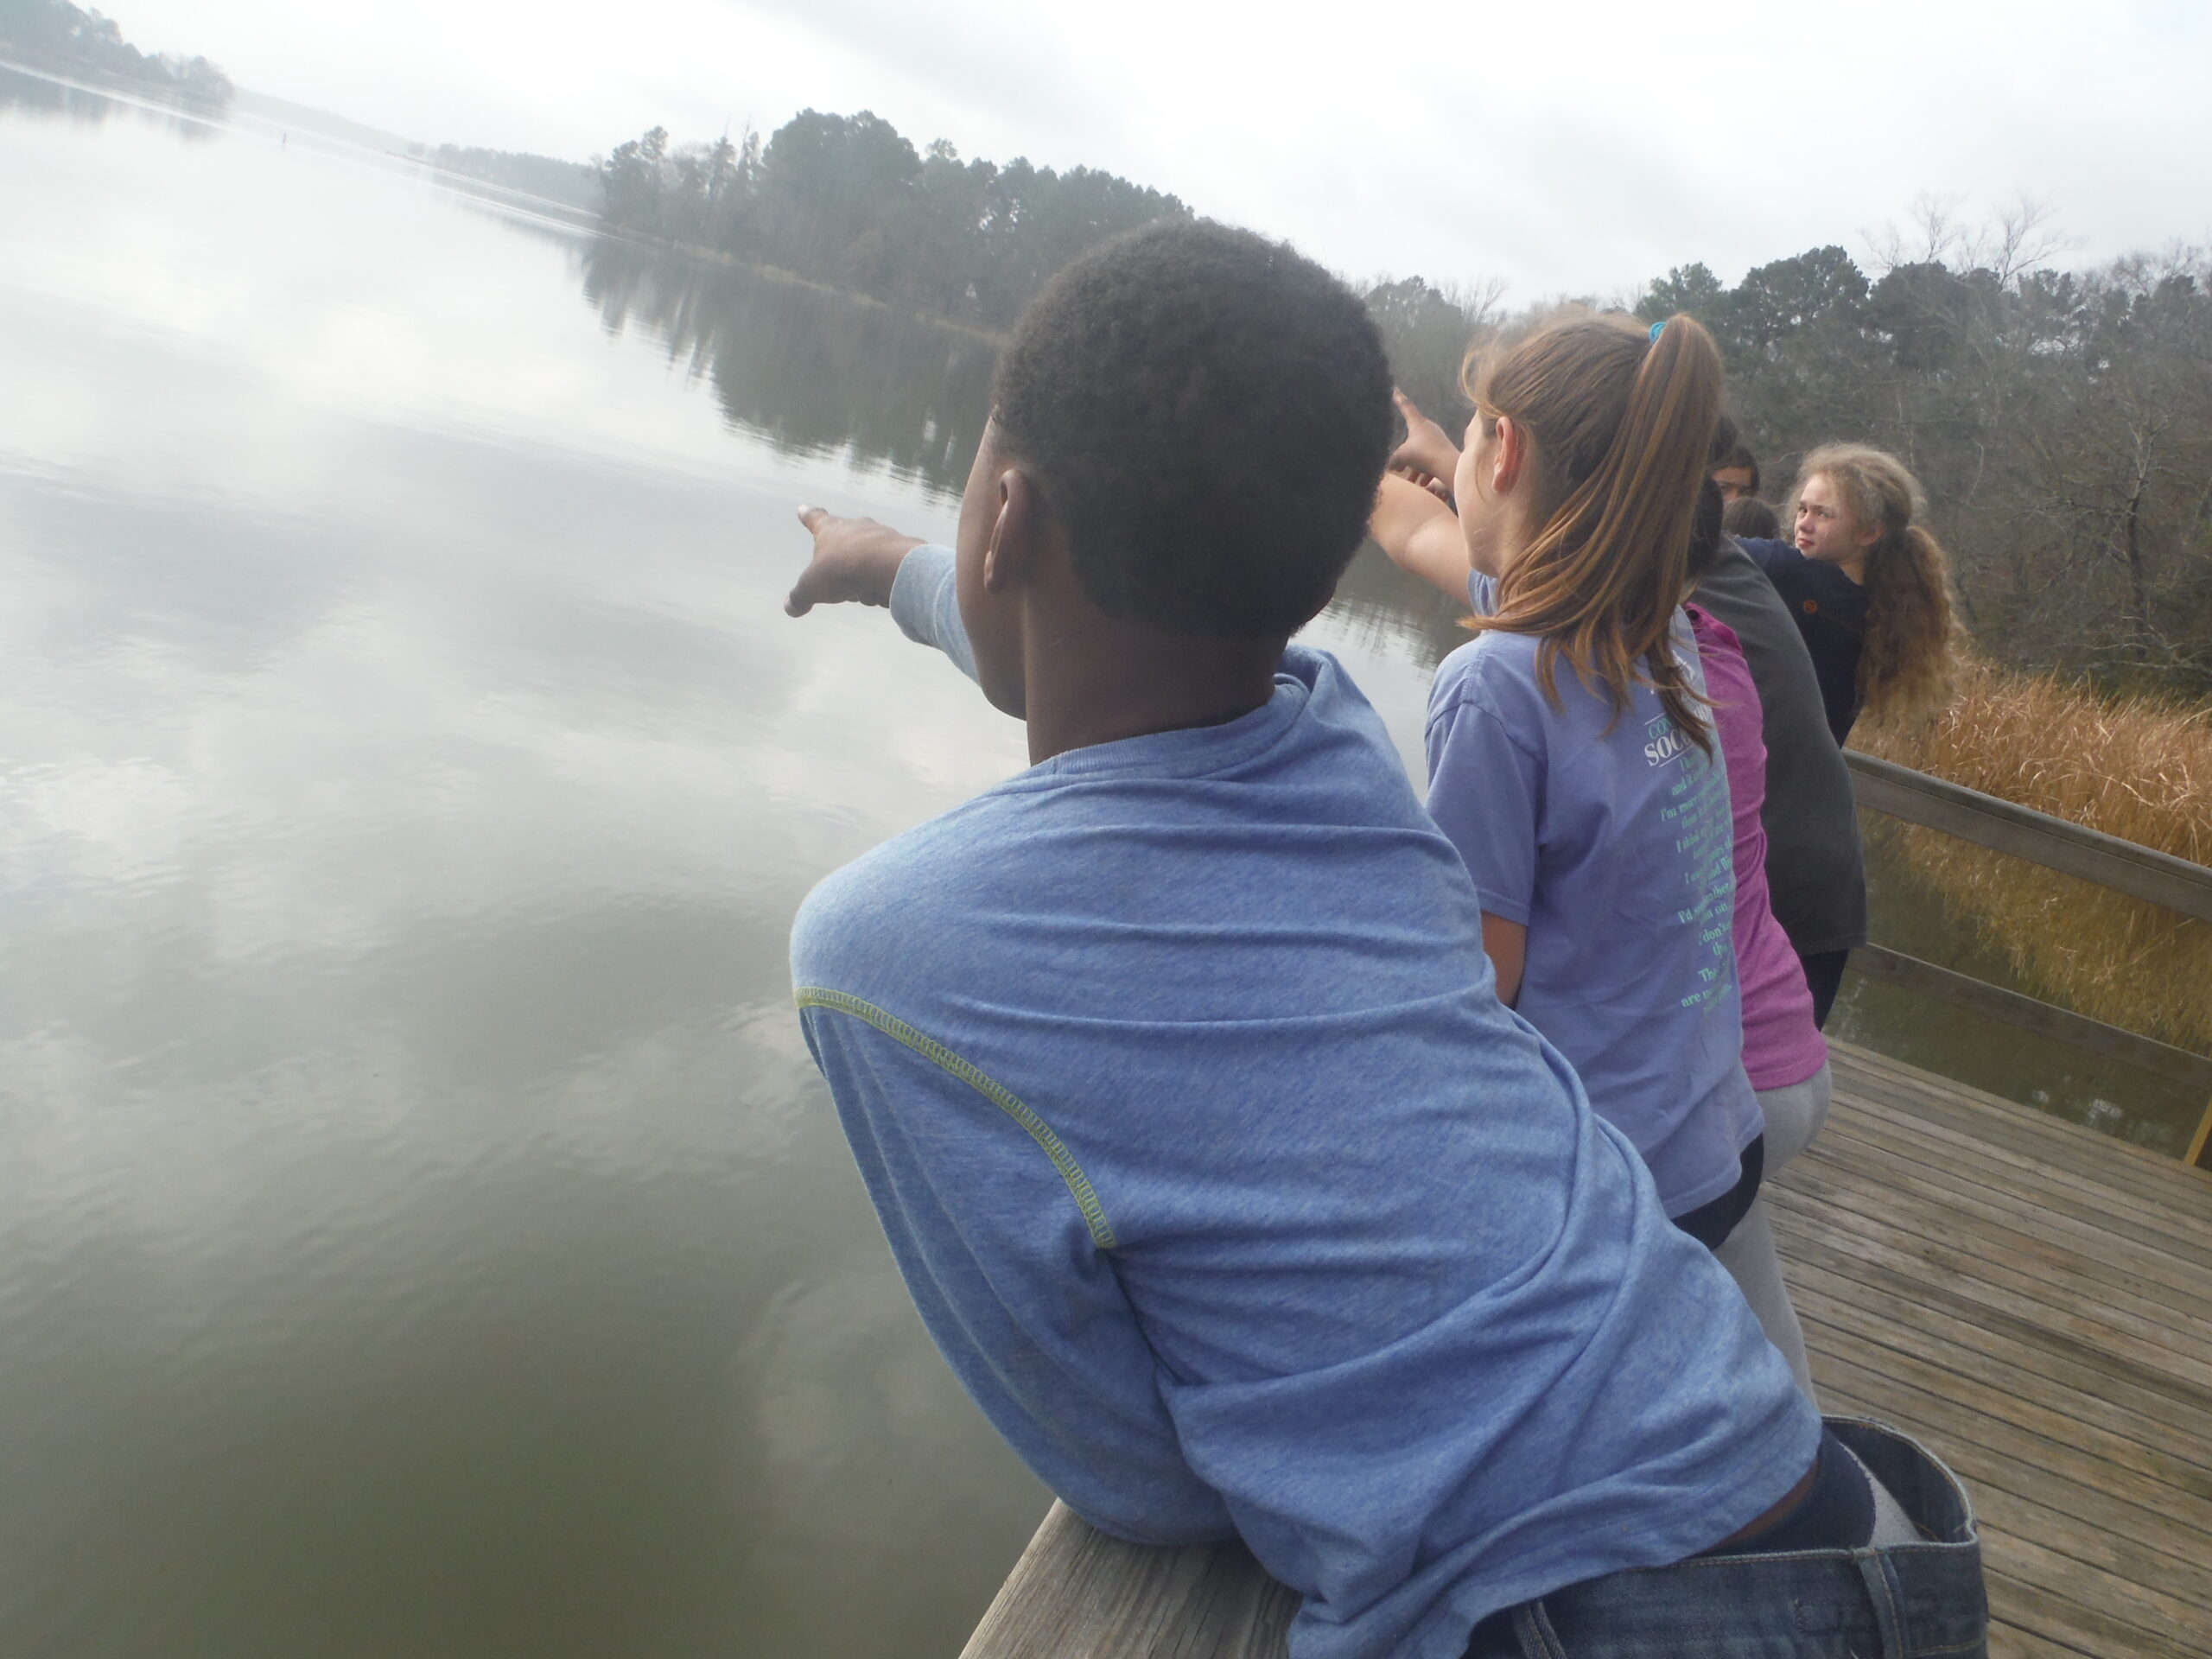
[{"xmin": 960, "ymin": 1502, "xmax": 1299, "ymax": 1659}]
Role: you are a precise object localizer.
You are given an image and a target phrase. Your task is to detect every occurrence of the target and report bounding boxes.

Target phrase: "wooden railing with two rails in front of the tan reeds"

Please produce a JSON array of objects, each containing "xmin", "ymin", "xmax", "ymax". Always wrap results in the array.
[{"xmin": 1842, "ymin": 750, "xmax": 2212, "ymax": 1168}]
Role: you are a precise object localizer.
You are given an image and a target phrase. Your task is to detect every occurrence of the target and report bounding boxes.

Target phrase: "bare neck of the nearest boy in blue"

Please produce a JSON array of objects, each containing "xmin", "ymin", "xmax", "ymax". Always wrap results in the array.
[{"xmin": 1024, "ymin": 615, "xmax": 1287, "ymax": 766}]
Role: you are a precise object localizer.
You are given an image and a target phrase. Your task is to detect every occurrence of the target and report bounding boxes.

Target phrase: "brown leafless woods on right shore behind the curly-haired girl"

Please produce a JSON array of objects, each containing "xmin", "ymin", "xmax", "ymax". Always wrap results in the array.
[{"xmin": 1637, "ymin": 210, "xmax": 2212, "ymax": 696}]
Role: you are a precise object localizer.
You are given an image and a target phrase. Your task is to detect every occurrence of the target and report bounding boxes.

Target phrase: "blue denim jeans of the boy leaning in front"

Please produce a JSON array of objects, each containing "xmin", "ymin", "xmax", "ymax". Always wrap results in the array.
[{"xmin": 1466, "ymin": 1418, "xmax": 1988, "ymax": 1659}]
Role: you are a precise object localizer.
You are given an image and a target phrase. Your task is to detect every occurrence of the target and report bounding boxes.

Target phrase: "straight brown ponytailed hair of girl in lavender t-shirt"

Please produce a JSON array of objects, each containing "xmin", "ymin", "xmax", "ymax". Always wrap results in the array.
[{"xmin": 1462, "ymin": 315, "xmax": 1721, "ymax": 754}]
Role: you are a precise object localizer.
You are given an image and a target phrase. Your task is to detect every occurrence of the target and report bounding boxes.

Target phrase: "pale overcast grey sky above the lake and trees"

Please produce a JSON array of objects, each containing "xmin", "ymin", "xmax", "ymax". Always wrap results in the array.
[{"xmin": 121, "ymin": 0, "xmax": 2212, "ymax": 301}]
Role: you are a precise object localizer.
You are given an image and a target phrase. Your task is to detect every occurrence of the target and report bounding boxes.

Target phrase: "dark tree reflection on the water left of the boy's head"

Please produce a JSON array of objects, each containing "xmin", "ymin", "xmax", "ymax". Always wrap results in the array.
[{"xmin": 580, "ymin": 237, "xmax": 998, "ymax": 491}]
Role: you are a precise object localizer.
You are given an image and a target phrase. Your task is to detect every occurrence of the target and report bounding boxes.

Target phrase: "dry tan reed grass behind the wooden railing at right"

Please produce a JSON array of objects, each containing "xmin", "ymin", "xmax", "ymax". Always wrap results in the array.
[{"xmin": 1853, "ymin": 657, "xmax": 2212, "ymax": 1053}]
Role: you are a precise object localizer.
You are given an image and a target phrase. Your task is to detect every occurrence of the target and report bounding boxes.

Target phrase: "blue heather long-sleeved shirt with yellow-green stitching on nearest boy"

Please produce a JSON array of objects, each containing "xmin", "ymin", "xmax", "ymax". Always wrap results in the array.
[{"xmin": 791, "ymin": 549, "xmax": 1818, "ymax": 1659}]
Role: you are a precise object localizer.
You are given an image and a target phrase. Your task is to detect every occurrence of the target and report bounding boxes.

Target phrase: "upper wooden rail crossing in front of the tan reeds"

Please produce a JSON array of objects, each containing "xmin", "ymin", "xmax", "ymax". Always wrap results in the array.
[{"xmin": 1842, "ymin": 750, "xmax": 2212, "ymax": 923}]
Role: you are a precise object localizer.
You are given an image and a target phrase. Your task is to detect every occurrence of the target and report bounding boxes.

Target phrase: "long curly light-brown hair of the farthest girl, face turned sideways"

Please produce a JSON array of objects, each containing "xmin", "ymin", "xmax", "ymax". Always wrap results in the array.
[{"xmin": 1792, "ymin": 445, "xmax": 1958, "ymax": 723}]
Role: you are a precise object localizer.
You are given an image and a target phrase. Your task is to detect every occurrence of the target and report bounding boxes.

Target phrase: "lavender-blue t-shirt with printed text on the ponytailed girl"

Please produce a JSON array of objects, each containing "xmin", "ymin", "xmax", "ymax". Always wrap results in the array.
[{"xmin": 1427, "ymin": 575, "xmax": 1763, "ymax": 1214}]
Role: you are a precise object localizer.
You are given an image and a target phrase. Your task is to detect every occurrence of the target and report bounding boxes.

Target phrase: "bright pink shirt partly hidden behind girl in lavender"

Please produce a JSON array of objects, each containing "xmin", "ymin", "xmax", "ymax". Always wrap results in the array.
[{"xmin": 1686, "ymin": 604, "xmax": 1827, "ymax": 1089}]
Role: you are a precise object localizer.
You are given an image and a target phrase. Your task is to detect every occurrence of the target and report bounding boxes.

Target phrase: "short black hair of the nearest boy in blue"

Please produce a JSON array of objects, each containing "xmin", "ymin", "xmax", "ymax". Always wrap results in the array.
[{"xmin": 995, "ymin": 219, "xmax": 1394, "ymax": 639}]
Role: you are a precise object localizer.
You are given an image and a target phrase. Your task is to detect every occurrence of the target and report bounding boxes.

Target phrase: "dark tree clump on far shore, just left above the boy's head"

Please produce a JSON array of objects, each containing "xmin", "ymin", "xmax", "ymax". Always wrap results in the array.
[{"xmin": 597, "ymin": 111, "xmax": 1190, "ymax": 327}]
